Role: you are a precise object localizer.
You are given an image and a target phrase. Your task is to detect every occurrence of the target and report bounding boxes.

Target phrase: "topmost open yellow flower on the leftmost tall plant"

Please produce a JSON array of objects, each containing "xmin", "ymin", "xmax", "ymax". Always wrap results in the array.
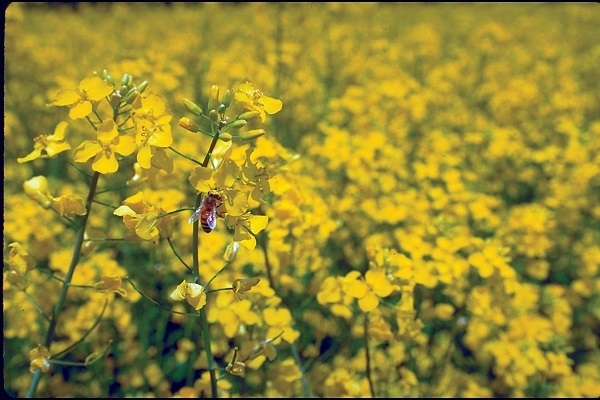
[{"xmin": 48, "ymin": 76, "xmax": 114, "ymax": 119}]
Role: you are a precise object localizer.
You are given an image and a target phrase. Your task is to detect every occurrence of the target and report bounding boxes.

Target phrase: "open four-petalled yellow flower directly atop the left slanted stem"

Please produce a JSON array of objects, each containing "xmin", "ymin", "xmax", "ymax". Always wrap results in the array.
[{"xmin": 73, "ymin": 120, "xmax": 135, "ymax": 174}]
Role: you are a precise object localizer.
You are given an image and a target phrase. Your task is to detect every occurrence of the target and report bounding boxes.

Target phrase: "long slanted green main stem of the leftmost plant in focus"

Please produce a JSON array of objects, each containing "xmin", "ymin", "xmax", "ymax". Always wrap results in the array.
[{"xmin": 27, "ymin": 172, "xmax": 100, "ymax": 397}]
